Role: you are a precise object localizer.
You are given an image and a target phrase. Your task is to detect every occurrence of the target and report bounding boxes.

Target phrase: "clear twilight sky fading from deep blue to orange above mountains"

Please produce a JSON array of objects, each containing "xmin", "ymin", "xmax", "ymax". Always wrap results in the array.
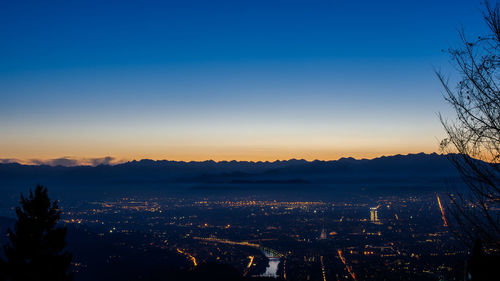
[{"xmin": 0, "ymin": 0, "xmax": 487, "ymax": 162}]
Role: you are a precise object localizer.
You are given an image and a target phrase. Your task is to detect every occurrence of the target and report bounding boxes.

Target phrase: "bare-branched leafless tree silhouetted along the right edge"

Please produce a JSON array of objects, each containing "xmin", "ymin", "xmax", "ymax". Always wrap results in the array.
[{"xmin": 437, "ymin": 2, "xmax": 500, "ymax": 249}]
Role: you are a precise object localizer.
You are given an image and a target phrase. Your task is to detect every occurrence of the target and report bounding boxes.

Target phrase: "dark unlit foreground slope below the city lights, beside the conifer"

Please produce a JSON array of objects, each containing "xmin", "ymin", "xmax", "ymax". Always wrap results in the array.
[{"xmin": 0, "ymin": 216, "xmax": 278, "ymax": 281}]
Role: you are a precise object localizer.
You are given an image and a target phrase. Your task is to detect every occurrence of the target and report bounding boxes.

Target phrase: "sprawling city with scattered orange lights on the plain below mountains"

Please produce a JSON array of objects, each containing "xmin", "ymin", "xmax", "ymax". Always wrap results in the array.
[{"xmin": 56, "ymin": 194, "xmax": 467, "ymax": 281}]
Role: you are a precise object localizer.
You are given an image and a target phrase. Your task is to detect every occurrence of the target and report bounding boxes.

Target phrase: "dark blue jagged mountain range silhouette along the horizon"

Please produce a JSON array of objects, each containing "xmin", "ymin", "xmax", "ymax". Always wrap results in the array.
[{"xmin": 0, "ymin": 153, "xmax": 461, "ymax": 200}]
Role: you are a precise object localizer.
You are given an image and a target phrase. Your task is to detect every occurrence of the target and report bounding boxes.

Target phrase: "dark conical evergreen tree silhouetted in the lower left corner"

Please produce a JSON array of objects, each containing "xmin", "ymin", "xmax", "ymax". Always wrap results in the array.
[{"xmin": 0, "ymin": 185, "xmax": 73, "ymax": 281}]
